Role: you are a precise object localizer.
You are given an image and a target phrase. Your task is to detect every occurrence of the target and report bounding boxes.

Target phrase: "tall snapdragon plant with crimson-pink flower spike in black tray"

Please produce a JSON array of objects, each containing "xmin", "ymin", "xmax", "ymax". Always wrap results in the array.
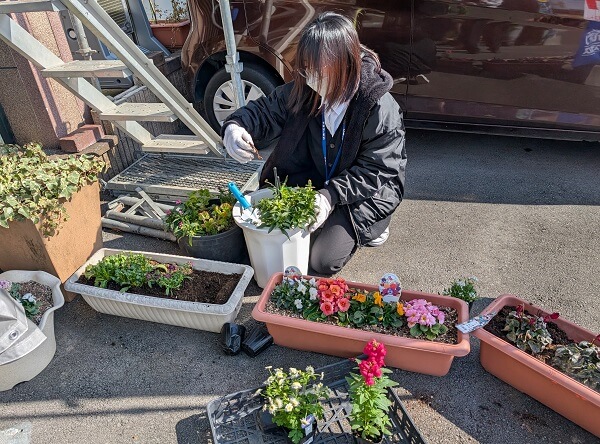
[{"xmin": 346, "ymin": 340, "xmax": 398, "ymax": 443}]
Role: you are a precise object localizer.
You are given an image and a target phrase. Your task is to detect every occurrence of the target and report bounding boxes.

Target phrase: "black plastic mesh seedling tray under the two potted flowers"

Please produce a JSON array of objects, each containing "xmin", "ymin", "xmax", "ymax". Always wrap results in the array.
[{"xmin": 206, "ymin": 359, "xmax": 426, "ymax": 444}]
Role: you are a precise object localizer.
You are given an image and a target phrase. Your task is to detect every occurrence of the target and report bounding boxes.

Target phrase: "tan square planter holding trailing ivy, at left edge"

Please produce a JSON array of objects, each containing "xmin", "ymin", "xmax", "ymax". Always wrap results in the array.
[{"xmin": 0, "ymin": 182, "xmax": 102, "ymax": 300}]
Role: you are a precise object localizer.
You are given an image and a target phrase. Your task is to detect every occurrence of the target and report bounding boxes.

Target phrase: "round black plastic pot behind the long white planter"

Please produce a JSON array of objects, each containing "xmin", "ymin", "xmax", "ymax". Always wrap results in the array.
[{"xmin": 177, "ymin": 225, "xmax": 248, "ymax": 264}]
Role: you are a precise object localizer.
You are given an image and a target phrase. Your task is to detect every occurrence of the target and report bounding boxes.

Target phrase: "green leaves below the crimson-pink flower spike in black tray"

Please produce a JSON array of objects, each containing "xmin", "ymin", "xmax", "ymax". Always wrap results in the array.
[{"xmin": 346, "ymin": 367, "xmax": 398, "ymax": 439}]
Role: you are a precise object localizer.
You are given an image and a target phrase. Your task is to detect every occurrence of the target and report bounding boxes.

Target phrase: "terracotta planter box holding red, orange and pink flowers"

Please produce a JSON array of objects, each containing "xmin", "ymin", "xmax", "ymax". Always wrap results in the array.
[{"xmin": 252, "ymin": 273, "xmax": 470, "ymax": 376}]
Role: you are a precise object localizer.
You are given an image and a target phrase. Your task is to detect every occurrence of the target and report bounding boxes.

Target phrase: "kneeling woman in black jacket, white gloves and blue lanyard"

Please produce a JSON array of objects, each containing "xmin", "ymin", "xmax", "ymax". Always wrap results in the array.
[{"xmin": 222, "ymin": 13, "xmax": 406, "ymax": 275}]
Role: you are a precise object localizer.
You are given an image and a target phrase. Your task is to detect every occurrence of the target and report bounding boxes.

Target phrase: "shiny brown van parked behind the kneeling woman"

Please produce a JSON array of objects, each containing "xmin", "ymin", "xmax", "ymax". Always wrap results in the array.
[{"xmin": 182, "ymin": 0, "xmax": 600, "ymax": 140}]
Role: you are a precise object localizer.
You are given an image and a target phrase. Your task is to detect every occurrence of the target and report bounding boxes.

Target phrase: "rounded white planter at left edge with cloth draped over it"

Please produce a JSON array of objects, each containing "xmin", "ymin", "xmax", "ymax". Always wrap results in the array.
[{"xmin": 0, "ymin": 270, "xmax": 65, "ymax": 391}]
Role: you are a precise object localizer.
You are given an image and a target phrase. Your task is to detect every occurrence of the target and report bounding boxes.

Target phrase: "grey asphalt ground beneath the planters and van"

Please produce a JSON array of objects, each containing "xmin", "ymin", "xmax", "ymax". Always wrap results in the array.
[{"xmin": 0, "ymin": 131, "xmax": 600, "ymax": 444}]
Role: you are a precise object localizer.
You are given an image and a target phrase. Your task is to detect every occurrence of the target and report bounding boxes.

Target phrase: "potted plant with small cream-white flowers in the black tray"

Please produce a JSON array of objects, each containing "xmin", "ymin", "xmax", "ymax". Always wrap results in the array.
[{"xmin": 262, "ymin": 366, "xmax": 329, "ymax": 443}]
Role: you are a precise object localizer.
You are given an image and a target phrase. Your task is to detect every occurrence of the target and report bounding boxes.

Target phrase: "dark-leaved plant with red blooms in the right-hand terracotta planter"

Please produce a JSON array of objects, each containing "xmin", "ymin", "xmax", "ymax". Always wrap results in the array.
[{"xmin": 503, "ymin": 305, "xmax": 552, "ymax": 355}]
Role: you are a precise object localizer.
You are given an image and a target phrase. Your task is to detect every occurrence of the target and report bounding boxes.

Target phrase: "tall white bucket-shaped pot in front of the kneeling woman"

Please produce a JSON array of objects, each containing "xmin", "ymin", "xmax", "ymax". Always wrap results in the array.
[{"xmin": 233, "ymin": 189, "xmax": 310, "ymax": 288}]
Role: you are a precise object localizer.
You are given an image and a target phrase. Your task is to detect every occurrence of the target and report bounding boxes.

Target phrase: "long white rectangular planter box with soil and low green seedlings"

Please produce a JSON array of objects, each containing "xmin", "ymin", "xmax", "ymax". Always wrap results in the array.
[{"xmin": 64, "ymin": 248, "xmax": 254, "ymax": 332}]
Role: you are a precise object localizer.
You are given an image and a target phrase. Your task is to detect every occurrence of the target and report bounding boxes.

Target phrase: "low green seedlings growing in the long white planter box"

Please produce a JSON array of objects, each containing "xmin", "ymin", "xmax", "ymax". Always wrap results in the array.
[{"xmin": 84, "ymin": 253, "xmax": 192, "ymax": 296}]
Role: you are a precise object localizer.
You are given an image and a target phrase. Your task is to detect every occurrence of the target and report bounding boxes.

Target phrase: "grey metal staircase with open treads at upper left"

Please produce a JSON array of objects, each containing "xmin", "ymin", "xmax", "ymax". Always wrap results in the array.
[{"xmin": 0, "ymin": 0, "xmax": 224, "ymax": 159}]
